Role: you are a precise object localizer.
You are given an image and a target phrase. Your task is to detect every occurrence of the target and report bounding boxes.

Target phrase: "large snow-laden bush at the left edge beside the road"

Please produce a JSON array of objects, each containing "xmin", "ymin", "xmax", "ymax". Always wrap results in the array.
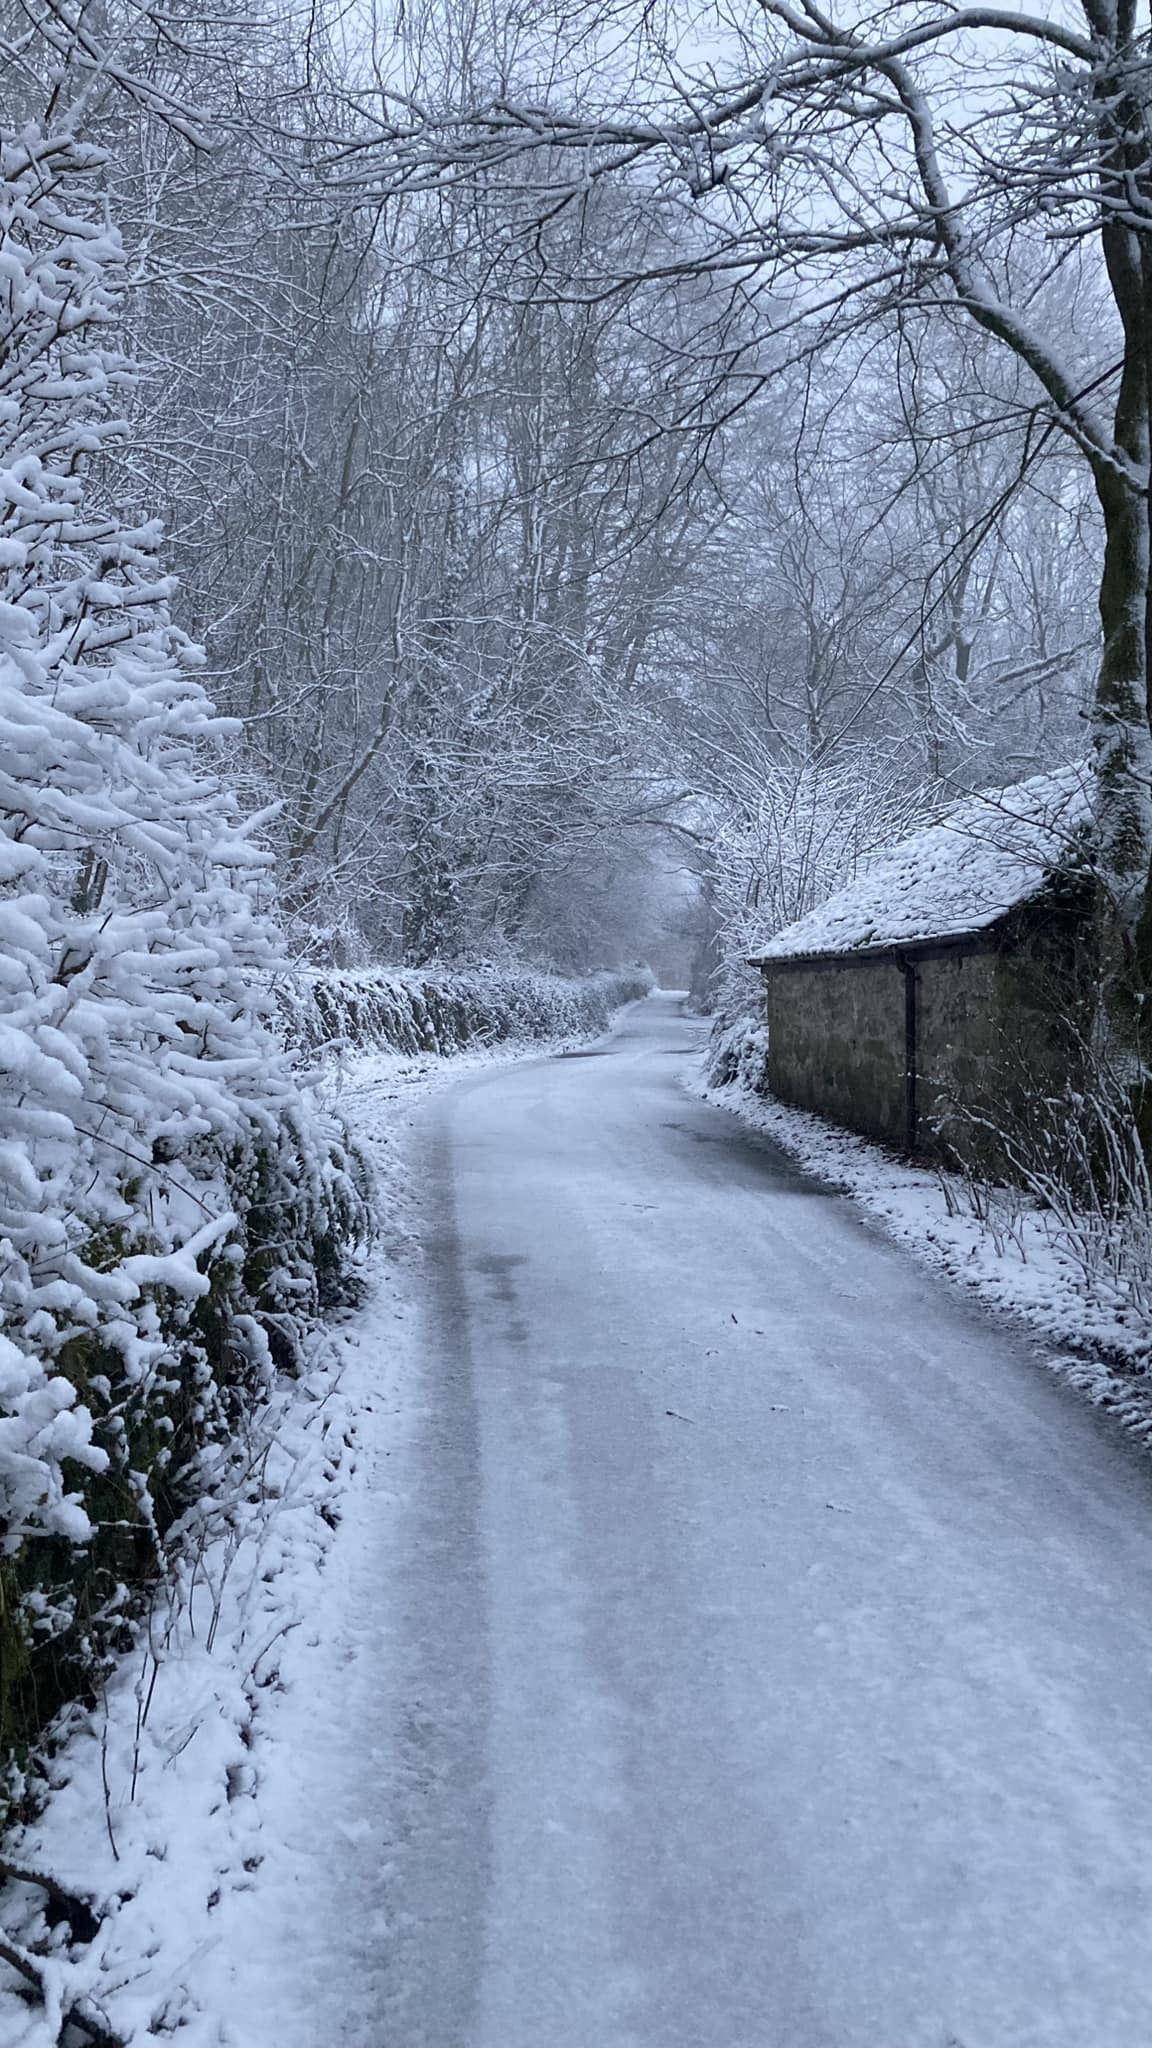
[{"xmin": 0, "ymin": 127, "xmax": 363, "ymax": 1794}]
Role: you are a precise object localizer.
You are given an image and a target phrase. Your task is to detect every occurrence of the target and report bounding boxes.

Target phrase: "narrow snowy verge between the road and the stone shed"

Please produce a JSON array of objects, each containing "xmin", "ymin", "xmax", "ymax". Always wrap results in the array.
[{"xmin": 693, "ymin": 1018, "xmax": 1152, "ymax": 1442}]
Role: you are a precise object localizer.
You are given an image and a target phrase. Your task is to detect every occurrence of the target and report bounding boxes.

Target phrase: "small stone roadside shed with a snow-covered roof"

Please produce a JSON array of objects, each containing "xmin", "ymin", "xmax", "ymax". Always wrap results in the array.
[{"xmin": 752, "ymin": 766, "xmax": 1093, "ymax": 1165}]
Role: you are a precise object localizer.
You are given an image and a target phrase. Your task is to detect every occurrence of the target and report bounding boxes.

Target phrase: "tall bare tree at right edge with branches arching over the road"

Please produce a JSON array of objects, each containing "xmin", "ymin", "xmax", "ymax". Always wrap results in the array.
[{"xmin": 327, "ymin": 0, "xmax": 1152, "ymax": 1032}]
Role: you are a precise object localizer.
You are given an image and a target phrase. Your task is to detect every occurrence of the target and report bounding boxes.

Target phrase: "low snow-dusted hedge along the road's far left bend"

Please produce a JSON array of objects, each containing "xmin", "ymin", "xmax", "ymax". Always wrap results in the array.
[{"xmin": 277, "ymin": 967, "xmax": 652, "ymax": 1055}]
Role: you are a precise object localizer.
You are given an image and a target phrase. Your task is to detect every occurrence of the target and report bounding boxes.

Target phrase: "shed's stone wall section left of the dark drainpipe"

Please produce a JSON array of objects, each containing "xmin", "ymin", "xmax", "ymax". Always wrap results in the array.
[{"xmin": 767, "ymin": 961, "xmax": 904, "ymax": 1145}]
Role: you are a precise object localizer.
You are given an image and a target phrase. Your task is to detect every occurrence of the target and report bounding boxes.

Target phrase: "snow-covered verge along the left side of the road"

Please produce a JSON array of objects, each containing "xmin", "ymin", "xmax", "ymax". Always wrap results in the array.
[{"xmin": 0, "ymin": 1047, "xmax": 565, "ymax": 2048}]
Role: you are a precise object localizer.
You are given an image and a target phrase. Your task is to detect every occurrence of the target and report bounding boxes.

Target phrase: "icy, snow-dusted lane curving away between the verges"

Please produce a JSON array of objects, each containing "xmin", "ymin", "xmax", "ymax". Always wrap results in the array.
[{"xmin": 253, "ymin": 997, "xmax": 1152, "ymax": 2048}]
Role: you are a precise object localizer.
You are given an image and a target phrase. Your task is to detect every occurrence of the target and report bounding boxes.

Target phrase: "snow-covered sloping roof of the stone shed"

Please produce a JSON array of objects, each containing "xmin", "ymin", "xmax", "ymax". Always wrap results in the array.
[{"xmin": 752, "ymin": 762, "xmax": 1091, "ymax": 965}]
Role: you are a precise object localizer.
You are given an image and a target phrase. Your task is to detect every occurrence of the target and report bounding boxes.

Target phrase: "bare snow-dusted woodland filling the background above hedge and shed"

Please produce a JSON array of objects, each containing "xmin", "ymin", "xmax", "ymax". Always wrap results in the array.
[{"xmin": 8, "ymin": 0, "xmax": 1123, "ymax": 1003}]
